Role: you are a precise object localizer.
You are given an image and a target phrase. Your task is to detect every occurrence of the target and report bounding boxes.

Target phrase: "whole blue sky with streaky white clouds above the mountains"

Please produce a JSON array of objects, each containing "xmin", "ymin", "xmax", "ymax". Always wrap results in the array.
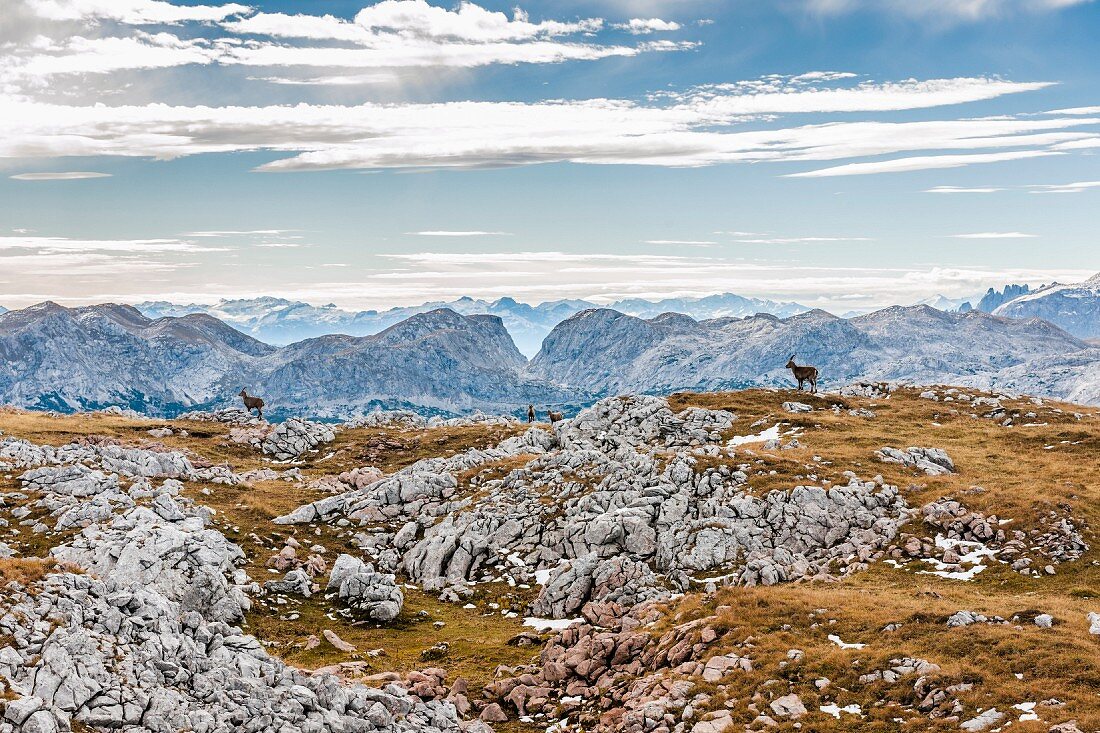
[{"xmin": 0, "ymin": 0, "xmax": 1100, "ymax": 314}]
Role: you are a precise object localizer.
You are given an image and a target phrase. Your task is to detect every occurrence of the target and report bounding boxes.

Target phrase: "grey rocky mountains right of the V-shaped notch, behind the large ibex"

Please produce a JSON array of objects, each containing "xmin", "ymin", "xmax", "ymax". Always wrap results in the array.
[{"xmin": 527, "ymin": 306, "xmax": 1100, "ymax": 396}]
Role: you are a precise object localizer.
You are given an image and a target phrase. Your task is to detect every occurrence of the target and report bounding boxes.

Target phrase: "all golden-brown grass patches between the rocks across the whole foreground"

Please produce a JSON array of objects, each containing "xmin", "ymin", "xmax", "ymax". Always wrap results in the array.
[{"xmin": 0, "ymin": 390, "xmax": 1100, "ymax": 731}]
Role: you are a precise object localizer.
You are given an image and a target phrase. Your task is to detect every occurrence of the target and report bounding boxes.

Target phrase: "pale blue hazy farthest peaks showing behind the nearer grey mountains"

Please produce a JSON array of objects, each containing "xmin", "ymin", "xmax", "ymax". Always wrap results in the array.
[{"xmin": 135, "ymin": 293, "xmax": 809, "ymax": 357}]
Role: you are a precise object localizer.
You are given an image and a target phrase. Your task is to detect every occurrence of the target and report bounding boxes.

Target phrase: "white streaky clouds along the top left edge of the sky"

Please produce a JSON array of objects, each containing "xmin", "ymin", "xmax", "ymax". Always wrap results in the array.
[{"xmin": 0, "ymin": 0, "xmax": 677, "ymax": 91}]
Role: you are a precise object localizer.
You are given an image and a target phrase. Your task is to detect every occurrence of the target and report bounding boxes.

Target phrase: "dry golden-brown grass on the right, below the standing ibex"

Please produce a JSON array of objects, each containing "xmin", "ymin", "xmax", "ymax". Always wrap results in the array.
[{"xmin": 670, "ymin": 390, "xmax": 1100, "ymax": 732}]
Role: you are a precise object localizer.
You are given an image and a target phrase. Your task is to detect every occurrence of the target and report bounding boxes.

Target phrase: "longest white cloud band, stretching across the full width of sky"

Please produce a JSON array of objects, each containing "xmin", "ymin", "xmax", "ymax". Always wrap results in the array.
[{"xmin": 0, "ymin": 79, "xmax": 1082, "ymax": 176}]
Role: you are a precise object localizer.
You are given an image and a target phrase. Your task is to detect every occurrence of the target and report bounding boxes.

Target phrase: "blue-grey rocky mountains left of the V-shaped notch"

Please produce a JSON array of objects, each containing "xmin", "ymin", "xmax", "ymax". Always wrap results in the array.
[{"xmin": 0, "ymin": 303, "xmax": 563, "ymax": 416}]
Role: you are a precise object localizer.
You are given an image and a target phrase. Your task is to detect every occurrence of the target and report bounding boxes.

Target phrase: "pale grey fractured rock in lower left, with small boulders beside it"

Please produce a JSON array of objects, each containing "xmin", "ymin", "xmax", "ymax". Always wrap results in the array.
[{"xmin": 0, "ymin": 431, "xmax": 461, "ymax": 733}]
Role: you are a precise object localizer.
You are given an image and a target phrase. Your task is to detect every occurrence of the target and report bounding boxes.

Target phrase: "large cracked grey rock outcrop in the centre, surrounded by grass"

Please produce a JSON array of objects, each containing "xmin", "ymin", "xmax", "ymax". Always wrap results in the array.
[{"xmin": 276, "ymin": 396, "xmax": 910, "ymax": 619}]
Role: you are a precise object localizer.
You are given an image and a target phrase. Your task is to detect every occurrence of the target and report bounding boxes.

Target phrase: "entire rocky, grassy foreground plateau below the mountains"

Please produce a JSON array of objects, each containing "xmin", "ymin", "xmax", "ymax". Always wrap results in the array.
[{"xmin": 0, "ymin": 385, "xmax": 1100, "ymax": 733}]
